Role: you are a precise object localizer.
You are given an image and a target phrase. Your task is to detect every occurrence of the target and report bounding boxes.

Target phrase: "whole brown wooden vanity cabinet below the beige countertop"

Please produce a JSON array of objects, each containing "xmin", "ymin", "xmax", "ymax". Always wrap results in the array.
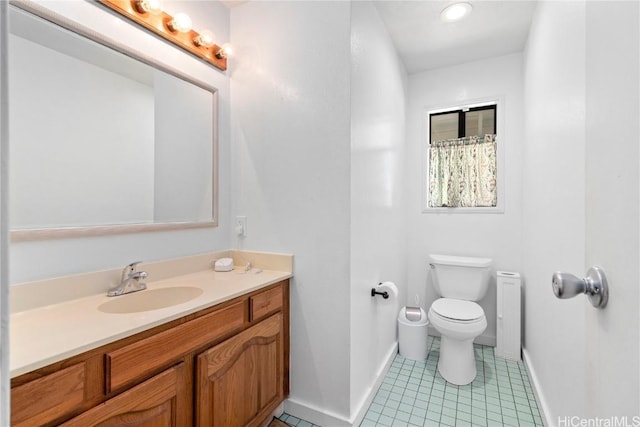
[{"xmin": 11, "ymin": 280, "xmax": 289, "ymax": 427}]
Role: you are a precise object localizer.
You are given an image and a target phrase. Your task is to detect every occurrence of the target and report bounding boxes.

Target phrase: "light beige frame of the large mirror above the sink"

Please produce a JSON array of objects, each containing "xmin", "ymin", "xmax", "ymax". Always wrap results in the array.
[{"xmin": 9, "ymin": 0, "xmax": 219, "ymax": 243}]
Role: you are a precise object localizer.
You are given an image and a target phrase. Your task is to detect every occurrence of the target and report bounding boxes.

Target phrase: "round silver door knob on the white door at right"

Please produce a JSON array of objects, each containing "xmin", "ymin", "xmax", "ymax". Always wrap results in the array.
[{"xmin": 551, "ymin": 267, "xmax": 609, "ymax": 308}]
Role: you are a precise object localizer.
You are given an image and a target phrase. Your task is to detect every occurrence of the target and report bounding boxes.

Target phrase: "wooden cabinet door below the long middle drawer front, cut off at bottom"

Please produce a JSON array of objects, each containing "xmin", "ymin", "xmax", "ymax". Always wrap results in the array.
[{"xmin": 62, "ymin": 363, "xmax": 187, "ymax": 427}]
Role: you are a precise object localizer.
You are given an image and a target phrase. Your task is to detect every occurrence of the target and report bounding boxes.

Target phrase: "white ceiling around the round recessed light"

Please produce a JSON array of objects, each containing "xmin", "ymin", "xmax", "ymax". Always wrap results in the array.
[{"xmin": 373, "ymin": 0, "xmax": 536, "ymax": 74}]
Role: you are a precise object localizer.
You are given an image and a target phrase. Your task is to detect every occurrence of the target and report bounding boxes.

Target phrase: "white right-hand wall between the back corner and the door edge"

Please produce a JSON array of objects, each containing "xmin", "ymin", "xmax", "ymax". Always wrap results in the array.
[{"xmin": 523, "ymin": 2, "xmax": 600, "ymax": 424}]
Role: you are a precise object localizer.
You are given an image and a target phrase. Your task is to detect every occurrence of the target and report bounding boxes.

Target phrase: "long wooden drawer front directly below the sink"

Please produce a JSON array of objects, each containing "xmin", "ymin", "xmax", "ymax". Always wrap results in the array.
[{"xmin": 106, "ymin": 301, "xmax": 246, "ymax": 393}]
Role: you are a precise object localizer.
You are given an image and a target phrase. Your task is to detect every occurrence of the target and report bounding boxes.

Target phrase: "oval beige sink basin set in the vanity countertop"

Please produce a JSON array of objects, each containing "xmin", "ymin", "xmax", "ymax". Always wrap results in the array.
[{"xmin": 98, "ymin": 286, "xmax": 202, "ymax": 314}]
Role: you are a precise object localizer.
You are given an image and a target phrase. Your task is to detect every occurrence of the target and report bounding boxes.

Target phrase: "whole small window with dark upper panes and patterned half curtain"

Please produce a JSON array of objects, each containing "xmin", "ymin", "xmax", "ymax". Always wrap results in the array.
[{"xmin": 427, "ymin": 103, "xmax": 498, "ymax": 208}]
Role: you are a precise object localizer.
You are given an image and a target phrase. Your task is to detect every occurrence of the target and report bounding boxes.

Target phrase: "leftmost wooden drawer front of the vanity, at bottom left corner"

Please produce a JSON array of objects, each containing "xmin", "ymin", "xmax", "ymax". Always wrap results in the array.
[{"xmin": 11, "ymin": 362, "xmax": 86, "ymax": 426}]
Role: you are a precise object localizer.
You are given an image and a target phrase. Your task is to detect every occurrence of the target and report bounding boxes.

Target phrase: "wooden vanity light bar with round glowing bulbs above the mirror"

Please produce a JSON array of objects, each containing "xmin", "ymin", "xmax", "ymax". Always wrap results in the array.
[{"xmin": 99, "ymin": 0, "xmax": 230, "ymax": 71}]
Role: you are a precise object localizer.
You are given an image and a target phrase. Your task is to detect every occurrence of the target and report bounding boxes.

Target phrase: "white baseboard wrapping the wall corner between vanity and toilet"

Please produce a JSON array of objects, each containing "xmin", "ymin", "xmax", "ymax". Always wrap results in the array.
[{"xmin": 284, "ymin": 341, "xmax": 398, "ymax": 427}]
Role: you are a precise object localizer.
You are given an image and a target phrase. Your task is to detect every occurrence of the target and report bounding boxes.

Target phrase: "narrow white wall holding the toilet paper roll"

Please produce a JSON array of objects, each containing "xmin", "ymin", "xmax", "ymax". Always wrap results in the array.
[{"xmin": 350, "ymin": 1, "xmax": 407, "ymax": 417}]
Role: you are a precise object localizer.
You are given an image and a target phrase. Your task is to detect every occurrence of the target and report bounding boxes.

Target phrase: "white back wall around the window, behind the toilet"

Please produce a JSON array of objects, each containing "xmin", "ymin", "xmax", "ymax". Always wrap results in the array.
[{"xmin": 406, "ymin": 54, "xmax": 524, "ymax": 345}]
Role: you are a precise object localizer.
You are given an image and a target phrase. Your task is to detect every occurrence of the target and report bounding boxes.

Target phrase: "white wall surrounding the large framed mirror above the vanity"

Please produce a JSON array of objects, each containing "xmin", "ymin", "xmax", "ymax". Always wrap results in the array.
[{"xmin": 9, "ymin": 0, "xmax": 231, "ymax": 283}]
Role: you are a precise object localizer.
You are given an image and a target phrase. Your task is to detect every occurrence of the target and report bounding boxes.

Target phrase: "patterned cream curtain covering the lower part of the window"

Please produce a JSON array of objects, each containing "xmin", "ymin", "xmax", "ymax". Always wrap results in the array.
[{"xmin": 429, "ymin": 135, "xmax": 498, "ymax": 208}]
